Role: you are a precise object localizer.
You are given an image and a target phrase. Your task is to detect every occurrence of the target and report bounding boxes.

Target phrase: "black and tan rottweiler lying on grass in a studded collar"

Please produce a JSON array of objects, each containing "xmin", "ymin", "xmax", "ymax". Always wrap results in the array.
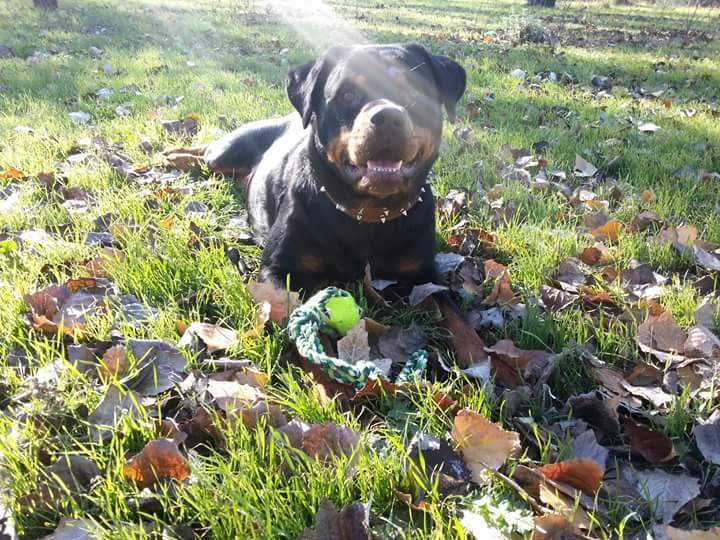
[{"xmin": 169, "ymin": 44, "xmax": 465, "ymax": 290}]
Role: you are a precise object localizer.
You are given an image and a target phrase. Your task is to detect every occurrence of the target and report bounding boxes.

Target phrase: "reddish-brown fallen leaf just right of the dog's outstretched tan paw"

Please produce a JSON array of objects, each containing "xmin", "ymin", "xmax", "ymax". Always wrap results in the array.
[{"xmin": 485, "ymin": 339, "xmax": 555, "ymax": 388}]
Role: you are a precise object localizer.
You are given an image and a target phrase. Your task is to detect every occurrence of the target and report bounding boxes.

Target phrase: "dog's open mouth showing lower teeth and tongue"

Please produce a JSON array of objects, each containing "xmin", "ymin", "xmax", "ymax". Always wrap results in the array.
[{"xmin": 345, "ymin": 151, "xmax": 417, "ymax": 198}]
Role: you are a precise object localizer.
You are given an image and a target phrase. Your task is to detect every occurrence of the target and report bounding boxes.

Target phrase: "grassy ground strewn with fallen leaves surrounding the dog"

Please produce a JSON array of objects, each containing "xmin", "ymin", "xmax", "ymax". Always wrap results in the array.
[{"xmin": 0, "ymin": 0, "xmax": 720, "ymax": 538}]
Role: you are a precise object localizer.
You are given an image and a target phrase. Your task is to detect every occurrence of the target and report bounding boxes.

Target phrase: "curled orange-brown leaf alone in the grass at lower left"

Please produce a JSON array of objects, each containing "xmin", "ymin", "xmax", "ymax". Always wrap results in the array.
[{"xmin": 123, "ymin": 439, "xmax": 190, "ymax": 489}]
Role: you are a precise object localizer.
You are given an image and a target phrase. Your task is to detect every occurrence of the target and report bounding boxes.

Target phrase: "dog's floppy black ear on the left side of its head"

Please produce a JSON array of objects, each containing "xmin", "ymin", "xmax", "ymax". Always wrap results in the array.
[{"xmin": 287, "ymin": 47, "xmax": 344, "ymax": 127}]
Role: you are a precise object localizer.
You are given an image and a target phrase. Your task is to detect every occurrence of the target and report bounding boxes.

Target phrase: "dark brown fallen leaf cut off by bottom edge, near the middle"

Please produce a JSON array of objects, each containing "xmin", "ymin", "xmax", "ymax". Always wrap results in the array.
[{"xmin": 297, "ymin": 499, "xmax": 381, "ymax": 540}]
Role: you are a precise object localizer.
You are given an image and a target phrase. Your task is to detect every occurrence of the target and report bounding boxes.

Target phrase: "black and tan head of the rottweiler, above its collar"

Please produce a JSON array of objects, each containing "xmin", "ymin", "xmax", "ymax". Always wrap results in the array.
[{"xmin": 287, "ymin": 44, "xmax": 466, "ymax": 218}]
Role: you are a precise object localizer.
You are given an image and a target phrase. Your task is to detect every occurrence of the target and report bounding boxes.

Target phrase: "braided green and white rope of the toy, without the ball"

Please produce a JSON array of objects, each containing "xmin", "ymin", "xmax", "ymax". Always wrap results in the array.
[{"xmin": 288, "ymin": 287, "xmax": 428, "ymax": 389}]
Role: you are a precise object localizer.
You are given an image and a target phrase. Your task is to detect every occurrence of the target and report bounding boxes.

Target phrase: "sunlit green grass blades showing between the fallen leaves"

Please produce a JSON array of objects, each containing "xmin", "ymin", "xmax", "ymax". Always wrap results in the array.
[{"xmin": 0, "ymin": 0, "xmax": 720, "ymax": 539}]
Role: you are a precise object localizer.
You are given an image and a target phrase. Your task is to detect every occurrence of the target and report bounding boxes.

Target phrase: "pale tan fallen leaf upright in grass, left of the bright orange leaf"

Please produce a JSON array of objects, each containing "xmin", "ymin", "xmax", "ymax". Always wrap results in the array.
[{"xmin": 452, "ymin": 409, "xmax": 521, "ymax": 485}]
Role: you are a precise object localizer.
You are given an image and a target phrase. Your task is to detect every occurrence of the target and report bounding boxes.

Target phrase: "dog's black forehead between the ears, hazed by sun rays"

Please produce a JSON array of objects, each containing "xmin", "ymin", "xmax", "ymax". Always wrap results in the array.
[{"xmin": 325, "ymin": 46, "xmax": 437, "ymax": 101}]
